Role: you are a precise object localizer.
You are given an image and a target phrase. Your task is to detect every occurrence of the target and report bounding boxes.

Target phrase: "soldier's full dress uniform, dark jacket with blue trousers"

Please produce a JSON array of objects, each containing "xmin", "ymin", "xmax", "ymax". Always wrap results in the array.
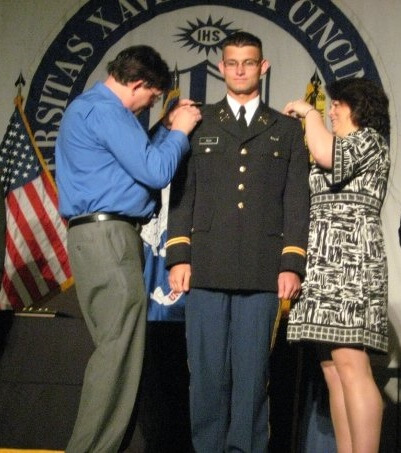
[{"xmin": 166, "ymin": 100, "xmax": 309, "ymax": 453}]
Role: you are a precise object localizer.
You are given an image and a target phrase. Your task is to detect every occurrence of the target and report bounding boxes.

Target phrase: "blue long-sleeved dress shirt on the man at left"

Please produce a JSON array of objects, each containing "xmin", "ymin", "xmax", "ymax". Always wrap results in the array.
[{"xmin": 56, "ymin": 82, "xmax": 189, "ymax": 219}]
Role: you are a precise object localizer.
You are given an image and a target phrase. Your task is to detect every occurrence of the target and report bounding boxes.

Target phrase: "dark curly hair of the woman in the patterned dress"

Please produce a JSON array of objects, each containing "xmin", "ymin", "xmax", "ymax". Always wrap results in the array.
[{"xmin": 326, "ymin": 78, "xmax": 390, "ymax": 137}]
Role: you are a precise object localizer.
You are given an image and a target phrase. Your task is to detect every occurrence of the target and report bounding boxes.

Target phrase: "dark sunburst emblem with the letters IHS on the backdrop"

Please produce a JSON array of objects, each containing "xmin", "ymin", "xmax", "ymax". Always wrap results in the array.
[{"xmin": 174, "ymin": 16, "xmax": 240, "ymax": 55}]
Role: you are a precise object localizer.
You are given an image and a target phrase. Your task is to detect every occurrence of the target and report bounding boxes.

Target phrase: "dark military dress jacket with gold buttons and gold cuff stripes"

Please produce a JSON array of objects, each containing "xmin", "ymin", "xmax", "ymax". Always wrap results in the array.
[{"xmin": 166, "ymin": 99, "xmax": 309, "ymax": 291}]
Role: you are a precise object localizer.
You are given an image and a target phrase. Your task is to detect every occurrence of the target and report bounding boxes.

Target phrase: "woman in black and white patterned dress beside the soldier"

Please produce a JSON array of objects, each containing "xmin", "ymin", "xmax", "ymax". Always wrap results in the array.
[{"xmin": 284, "ymin": 78, "xmax": 390, "ymax": 453}]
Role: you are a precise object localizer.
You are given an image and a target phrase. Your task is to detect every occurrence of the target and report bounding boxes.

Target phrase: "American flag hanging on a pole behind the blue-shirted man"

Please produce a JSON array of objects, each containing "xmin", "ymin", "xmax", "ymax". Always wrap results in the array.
[{"xmin": 0, "ymin": 96, "xmax": 71, "ymax": 310}]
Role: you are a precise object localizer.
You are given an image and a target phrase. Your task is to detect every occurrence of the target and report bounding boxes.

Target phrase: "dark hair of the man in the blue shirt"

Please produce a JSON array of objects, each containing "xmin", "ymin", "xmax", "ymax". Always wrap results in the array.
[{"xmin": 107, "ymin": 46, "xmax": 171, "ymax": 91}]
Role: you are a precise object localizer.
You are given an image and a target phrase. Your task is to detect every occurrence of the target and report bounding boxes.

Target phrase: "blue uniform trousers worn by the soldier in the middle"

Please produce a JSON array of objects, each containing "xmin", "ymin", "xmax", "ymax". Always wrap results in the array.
[{"xmin": 185, "ymin": 288, "xmax": 279, "ymax": 453}]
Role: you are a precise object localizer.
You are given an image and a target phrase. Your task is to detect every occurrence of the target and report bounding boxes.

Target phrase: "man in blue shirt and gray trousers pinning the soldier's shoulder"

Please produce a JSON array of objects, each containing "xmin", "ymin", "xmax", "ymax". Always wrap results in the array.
[{"xmin": 56, "ymin": 46, "xmax": 201, "ymax": 453}]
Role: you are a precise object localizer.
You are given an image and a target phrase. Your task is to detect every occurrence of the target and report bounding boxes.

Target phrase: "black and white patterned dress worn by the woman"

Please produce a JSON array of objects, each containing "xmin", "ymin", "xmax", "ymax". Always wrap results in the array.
[{"xmin": 287, "ymin": 128, "xmax": 390, "ymax": 352}]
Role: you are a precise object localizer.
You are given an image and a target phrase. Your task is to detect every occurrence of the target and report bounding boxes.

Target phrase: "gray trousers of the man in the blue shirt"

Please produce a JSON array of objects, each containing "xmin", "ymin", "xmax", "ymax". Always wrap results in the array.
[{"xmin": 66, "ymin": 217, "xmax": 146, "ymax": 453}]
